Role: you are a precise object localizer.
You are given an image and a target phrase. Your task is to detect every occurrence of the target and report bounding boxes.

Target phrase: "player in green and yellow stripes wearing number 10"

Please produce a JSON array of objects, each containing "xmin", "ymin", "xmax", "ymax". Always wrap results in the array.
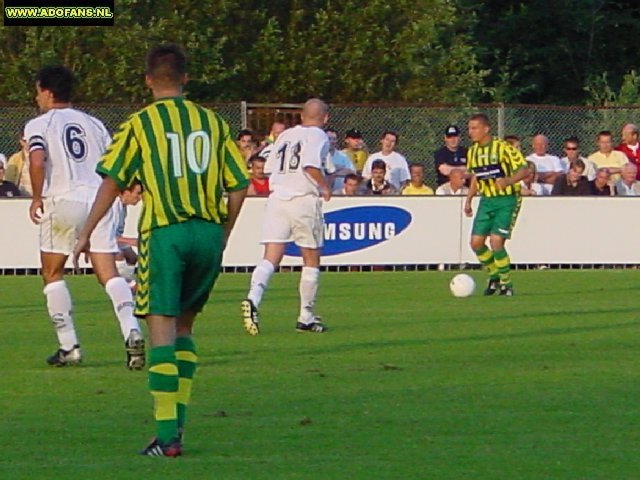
[{"xmin": 74, "ymin": 45, "xmax": 249, "ymax": 457}]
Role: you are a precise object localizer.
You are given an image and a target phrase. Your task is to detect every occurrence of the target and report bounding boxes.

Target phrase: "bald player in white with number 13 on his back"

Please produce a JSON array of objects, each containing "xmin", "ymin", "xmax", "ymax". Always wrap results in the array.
[{"xmin": 242, "ymin": 98, "xmax": 331, "ymax": 335}]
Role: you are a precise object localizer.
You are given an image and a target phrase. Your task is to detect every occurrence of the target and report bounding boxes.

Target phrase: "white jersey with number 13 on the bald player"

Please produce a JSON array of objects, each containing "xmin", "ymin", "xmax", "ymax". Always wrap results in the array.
[{"xmin": 264, "ymin": 125, "xmax": 329, "ymax": 200}]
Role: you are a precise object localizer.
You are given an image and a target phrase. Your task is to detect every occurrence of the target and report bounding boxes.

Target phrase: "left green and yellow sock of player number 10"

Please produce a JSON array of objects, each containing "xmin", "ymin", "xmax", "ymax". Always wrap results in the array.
[{"xmin": 149, "ymin": 345, "xmax": 178, "ymax": 444}]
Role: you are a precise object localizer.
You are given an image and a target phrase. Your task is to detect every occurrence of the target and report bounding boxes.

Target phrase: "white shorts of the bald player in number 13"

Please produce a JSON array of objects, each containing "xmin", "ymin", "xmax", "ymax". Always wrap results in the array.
[{"xmin": 261, "ymin": 195, "xmax": 324, "ymax": 248}]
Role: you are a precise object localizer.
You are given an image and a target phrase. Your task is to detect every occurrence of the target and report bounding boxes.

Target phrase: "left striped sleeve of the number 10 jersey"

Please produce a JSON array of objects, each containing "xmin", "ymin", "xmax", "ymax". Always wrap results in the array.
[{"xmin": 96, "ymin": 119, "xmax": 141, "ymax": 190}]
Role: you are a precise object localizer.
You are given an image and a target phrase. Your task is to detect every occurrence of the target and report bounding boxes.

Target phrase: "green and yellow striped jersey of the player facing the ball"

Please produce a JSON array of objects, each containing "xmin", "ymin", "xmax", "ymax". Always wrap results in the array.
[{"xmin": 467, "ymin": 138, "xmax": 527, "ymax": 197}]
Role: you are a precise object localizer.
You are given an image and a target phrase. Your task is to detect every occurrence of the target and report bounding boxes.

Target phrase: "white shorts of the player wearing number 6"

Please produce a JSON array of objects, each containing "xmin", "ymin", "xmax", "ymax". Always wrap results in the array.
[{"xmin": 40, "ymin": 197, "xmax": 118, "ymax": 255}]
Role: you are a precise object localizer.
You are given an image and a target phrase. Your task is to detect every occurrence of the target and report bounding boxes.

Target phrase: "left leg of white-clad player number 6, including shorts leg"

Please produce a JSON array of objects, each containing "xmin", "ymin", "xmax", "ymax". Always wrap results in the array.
[{"xmin": 40, "ymin": 198, "xmax": 84, "ymax": 366}]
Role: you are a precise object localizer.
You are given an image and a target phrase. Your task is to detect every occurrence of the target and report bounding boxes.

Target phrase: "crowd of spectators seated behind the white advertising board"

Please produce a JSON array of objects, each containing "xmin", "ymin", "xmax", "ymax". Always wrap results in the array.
[{"xmin": 0, "ymin": 121, "xmax": 640, "ymax": 197}]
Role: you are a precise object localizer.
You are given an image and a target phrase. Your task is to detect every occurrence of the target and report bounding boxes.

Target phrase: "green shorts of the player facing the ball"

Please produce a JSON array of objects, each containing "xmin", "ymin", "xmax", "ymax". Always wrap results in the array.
[{"xmin": 471, "ymin": 195, "xmax": 522, "ymax": 238}]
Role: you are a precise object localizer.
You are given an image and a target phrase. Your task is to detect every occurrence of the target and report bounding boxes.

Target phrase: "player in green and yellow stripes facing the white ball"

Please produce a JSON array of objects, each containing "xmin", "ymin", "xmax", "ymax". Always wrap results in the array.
[{"xmin": 464, "ymin": 113, "xmax": 529, "ymax": 296}]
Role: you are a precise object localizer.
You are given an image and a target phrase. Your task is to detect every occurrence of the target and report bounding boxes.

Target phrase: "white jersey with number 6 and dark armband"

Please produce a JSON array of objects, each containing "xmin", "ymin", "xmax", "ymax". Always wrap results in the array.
[{"xmin": 25, "ymin": 108, "xmax": 111, "ymax": 197}]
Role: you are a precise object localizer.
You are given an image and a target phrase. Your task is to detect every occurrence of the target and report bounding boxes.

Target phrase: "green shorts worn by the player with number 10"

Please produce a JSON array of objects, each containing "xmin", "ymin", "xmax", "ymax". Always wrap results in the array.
[{"xmin": 135, "ymin": 219, "xmax": 224, "ymax": 317}]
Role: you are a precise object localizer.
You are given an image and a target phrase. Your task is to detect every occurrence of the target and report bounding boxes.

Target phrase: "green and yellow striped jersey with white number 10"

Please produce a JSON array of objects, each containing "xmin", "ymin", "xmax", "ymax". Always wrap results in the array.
[{"xmin": 96, "ymin": 97, "xmax": 249, "ymax": 232}]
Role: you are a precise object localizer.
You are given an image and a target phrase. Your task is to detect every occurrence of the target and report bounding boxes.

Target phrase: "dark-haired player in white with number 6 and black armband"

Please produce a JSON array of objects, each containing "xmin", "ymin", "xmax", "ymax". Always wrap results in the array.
[{"xmin": 25, "ymin": 66, "xmax": 145, "ymax": 370}]
